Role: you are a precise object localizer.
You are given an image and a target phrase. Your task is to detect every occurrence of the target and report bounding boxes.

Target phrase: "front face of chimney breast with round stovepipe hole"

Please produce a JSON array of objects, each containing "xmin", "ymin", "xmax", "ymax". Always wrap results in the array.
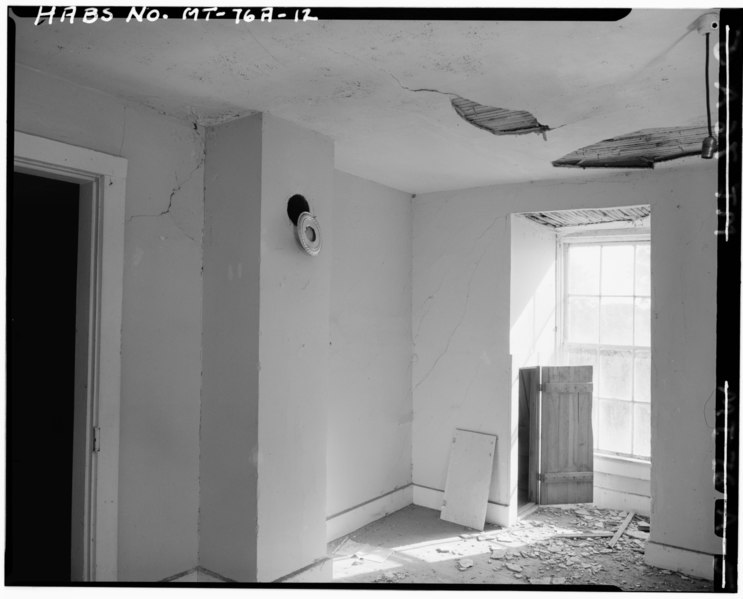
[{"xmin": 257, "ymin": 114, "xmax": 334, "ymax": 581}]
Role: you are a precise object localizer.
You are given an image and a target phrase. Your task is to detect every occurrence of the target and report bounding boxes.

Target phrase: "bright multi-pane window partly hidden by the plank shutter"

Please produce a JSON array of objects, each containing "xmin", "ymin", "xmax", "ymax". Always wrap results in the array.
[{"xmin": 562, "ymin": 236, "xmax": 650, "ymax": 460}]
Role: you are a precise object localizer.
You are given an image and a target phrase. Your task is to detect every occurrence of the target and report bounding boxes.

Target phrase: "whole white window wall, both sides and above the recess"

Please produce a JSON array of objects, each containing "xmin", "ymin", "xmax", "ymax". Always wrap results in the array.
[{"xmin": 413, "ymin": 159, "xmax": 718, "ymax": 564}]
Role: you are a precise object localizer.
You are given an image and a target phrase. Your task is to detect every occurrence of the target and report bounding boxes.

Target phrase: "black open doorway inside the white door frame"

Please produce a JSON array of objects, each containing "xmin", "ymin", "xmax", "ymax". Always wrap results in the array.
[{"xmin": 5, "ymin": 173, "xmax": 80, "ymax": 585}]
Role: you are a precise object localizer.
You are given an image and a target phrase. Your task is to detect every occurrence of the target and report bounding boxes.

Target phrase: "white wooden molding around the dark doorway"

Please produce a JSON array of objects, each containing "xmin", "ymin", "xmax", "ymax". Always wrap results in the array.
[{"xmin": 13, "ymin": 131, "xmax": 127, "ymax": 582}]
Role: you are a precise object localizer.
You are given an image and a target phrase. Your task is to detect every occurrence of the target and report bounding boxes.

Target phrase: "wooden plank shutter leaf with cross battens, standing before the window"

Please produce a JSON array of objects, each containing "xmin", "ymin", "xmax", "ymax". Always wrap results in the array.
[{"xmin": 539, "ymin": 366, "xmax": 593, "ymax": 505}]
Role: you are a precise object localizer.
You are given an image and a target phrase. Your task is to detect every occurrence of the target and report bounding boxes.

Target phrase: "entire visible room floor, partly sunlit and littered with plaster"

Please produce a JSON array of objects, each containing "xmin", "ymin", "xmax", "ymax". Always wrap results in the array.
[{"xmin": 328, "ymin": 504, "xmax": 712, "ymax": 592}]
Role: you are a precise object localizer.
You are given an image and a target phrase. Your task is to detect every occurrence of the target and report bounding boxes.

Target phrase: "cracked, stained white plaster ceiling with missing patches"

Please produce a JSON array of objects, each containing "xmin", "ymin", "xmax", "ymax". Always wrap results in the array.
[{"xmin": 10, "ymin": 9, "xmax": 716, "ymax": 193}]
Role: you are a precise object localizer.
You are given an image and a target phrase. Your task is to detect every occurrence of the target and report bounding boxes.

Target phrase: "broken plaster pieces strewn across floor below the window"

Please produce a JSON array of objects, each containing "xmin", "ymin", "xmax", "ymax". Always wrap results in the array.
[{"xmin": 334, "ymin": 504, "xmax": 712, "ymax": 592}]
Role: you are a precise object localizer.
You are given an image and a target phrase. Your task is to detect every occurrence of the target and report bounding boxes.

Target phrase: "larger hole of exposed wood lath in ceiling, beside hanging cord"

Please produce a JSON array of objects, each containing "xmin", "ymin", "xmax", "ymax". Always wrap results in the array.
[{"xmin": 552, "ymin": 126, "xmax": 707, "ymax": 168}]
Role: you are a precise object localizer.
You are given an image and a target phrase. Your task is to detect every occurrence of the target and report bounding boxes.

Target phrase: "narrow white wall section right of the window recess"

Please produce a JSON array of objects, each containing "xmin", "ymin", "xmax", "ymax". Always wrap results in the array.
[{"xmin": 650, "ymin": 168, "xmax": 720, "ymax": 553}]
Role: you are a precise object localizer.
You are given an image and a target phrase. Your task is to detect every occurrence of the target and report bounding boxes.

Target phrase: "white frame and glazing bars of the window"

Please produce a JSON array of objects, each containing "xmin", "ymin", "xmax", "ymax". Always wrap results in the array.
[{"xmin": 555, "ymin": 232, "xmax": 652, "ymax": 463}]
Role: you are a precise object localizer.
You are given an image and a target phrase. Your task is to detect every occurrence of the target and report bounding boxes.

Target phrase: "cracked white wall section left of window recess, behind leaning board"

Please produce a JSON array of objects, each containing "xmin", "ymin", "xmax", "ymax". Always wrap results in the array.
[{"xmin": 412, "ymin": 191, "xmax": 516, "ymax": 505}]
